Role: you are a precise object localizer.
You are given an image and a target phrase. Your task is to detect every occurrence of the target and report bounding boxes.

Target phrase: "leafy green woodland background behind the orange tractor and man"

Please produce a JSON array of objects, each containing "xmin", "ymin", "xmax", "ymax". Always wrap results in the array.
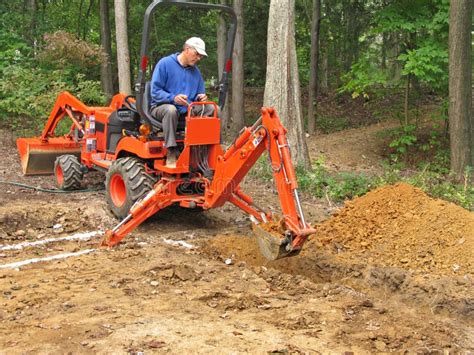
[{"xmin": 0, "ymin": 0, "xmax": 474, "ymax": 209}]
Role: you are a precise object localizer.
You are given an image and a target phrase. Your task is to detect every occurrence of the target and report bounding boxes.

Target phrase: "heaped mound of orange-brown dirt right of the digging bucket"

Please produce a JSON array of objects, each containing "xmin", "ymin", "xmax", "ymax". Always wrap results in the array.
[{"xmin": 312, "ymin": 183, "xmax": 474, "ymax": 275}]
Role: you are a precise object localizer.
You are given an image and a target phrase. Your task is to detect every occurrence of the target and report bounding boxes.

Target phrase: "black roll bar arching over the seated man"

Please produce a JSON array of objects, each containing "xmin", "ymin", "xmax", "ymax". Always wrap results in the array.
[{"xmin": 135, "ymin": 0, "xmax": 237, "ymax": 127}]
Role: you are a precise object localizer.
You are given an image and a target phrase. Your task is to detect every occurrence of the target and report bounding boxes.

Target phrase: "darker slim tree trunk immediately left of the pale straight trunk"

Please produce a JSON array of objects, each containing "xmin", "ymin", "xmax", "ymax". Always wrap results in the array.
[{"xmin": 99, "ymin": 0, "xmax": 114, "ymax": 99}]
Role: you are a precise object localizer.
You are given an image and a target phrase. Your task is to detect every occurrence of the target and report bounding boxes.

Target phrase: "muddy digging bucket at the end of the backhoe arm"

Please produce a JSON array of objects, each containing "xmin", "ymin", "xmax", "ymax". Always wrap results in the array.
[{"xmin": 252, "ymin": 222, "xmax": 300, "ymax": 260}]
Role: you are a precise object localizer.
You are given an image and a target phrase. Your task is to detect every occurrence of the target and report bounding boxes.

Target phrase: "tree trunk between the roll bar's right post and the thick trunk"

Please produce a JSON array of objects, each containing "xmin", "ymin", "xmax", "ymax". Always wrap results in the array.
[{"xmin": 232, "ymin": 0, "xmax": 245, "ymax": 133}]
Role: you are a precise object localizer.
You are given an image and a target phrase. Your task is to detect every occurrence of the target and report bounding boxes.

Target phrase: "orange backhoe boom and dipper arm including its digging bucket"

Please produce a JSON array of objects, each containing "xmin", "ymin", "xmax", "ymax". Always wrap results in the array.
[{"xmin": 204, "ymin": 108, "xmax": 316, "ymax": 259}]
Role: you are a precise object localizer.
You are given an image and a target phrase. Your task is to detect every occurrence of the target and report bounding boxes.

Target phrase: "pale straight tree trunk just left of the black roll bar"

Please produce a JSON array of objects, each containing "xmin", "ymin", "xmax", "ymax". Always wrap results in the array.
[{"xmin": 114, "ymin": 0, "xmax": 132, "ymax": 95}]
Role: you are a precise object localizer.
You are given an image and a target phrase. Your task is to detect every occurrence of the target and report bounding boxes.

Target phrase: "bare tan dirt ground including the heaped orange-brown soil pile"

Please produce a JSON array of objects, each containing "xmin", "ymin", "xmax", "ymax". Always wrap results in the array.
[{"xmin": 0, "ymin": 126, "xmax": 474, "ymax": 354}]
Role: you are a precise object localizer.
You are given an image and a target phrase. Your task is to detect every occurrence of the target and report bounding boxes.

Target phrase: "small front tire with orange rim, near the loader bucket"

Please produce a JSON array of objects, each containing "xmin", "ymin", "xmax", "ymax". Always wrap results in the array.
[{"xmin": 54, "ymin": 154, "xmax": 84, "ymax": 191}]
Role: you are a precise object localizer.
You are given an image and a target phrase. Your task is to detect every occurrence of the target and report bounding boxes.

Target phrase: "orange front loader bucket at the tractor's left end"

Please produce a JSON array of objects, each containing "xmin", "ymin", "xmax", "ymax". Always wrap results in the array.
[{"xmin": 16, "ymin": 137, "xmax": 81, "ymax": 175}]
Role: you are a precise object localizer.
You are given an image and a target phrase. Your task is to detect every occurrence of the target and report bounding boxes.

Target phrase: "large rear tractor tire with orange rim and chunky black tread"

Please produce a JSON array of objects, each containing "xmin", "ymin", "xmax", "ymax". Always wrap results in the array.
[{"xmin": 105, "ymin": 157, "xmax": 156, "ymax": 219}]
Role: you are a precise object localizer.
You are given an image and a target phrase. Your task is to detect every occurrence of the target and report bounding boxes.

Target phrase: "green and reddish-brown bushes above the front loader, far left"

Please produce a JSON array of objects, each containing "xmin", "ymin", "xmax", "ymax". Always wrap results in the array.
[{"xmin": 0, "ymin": 28, "xmax": 105, "ymax": 134}]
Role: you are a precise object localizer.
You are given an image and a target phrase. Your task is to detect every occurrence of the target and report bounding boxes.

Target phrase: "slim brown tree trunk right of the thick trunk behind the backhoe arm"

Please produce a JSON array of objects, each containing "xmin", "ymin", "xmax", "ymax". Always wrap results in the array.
[{"xmin": 308, "ymin": 0, "xmax": 321, "ymax": 134}]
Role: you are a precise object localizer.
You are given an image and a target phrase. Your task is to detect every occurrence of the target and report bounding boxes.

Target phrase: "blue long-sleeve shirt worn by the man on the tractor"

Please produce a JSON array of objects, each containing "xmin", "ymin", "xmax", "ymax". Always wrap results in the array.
[{"xmin": 151, "ymin": 53, "xmax": 206, "ymax": 113}]
